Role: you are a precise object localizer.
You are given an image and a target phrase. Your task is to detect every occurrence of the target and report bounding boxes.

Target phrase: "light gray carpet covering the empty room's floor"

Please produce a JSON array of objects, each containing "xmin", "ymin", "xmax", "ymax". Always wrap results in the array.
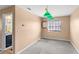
[{"xmin": 21, "ymin": 39, "xmax": 77, "ymax": 54}]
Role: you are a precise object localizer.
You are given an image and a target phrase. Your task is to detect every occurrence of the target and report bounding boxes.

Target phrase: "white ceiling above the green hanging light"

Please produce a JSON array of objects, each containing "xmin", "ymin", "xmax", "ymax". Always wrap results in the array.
[{"xmin": 20, "ymin": 5, "xmax": 79, "ymax": 17}]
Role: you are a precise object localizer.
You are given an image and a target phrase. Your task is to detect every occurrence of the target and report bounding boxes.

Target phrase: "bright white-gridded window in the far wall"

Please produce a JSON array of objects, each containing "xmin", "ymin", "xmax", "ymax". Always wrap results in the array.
[{"xmin": 47, "ymin": 20, "xmax": 61, "ymax": 32}]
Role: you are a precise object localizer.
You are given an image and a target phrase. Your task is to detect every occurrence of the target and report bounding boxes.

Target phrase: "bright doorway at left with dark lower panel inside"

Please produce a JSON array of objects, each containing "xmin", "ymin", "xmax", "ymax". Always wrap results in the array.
[{"xmin": 2, "ymin": 13, "xmax": 13, "ymax": 53}]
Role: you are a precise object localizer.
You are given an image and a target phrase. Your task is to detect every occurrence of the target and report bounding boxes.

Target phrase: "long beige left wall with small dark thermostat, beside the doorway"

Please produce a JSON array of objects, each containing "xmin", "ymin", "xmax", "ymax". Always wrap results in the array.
[{"xmin": 15, "ymin": 6, "xmax": 41, "ymax": 53}]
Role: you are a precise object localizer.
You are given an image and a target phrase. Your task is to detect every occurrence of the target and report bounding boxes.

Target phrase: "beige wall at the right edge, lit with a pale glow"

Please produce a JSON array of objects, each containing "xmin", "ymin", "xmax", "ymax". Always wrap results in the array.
[{"xmin": 70, "ymin": 8, "xmax": 79, "ymax": 50}]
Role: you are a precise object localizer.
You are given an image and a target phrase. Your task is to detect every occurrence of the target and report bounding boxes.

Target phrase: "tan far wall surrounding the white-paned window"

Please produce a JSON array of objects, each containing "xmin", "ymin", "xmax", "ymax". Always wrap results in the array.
[{"xmin": 42, "ymin": 16, "xmax": 70, "ymax": 41}]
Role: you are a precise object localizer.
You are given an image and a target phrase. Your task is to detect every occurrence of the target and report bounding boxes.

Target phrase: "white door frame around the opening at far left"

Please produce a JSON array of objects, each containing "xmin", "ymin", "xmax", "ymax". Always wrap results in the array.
[{"xmin": 2, "ymin": 13, "xmax": 14, "ymax": 50}]
